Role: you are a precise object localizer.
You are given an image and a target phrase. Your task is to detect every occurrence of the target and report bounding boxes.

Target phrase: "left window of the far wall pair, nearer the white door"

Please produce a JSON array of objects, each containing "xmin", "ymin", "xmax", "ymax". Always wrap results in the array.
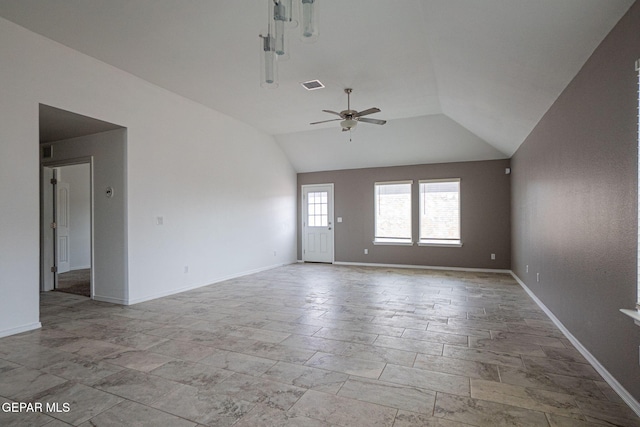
[{"xmin": 374, "ymin": 181, "xmax": 413, "ymax": 245}]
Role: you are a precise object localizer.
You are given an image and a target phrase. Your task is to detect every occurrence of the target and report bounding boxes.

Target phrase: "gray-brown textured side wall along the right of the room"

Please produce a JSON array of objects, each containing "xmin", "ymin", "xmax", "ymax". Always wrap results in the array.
[{"xmin": 512, "ymin": 2, "xmax": 640, "ymax": 400}]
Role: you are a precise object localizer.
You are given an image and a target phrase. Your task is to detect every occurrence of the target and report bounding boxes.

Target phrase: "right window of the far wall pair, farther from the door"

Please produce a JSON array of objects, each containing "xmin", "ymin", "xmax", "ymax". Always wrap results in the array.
[{"xmin": 418, "ymin": 179, "xmax": 462, "ymax": 246}]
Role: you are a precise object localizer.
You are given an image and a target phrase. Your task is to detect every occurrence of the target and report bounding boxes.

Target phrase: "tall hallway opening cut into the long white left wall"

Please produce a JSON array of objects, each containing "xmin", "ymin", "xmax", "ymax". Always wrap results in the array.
[{"xmin": 39, "ymin": 104, "xmax": 127, "ymax": 303}]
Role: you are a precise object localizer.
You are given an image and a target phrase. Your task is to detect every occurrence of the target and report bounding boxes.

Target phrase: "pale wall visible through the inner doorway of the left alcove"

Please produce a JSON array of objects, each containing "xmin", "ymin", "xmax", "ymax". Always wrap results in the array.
[{"xmin": 54, "ymin": 164, "xmax": 91, "ymax": 270}]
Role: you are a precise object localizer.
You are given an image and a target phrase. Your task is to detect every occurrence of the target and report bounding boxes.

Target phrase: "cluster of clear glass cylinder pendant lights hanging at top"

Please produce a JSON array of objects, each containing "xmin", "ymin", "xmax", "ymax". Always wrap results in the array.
[{"xmin": 260, "ymin": 0, "xmax": 318, "ymax": 89}]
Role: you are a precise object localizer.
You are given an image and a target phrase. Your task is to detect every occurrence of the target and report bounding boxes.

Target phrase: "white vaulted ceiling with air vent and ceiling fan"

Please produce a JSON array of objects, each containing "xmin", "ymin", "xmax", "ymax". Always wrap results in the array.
[{"xmin": 0, "ymin": 0, "xmax": 633, "ymax": 172}]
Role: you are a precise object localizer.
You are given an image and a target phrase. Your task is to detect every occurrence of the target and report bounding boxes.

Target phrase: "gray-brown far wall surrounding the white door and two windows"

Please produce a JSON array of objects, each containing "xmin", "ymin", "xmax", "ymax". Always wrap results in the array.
[{"xmin": 298, "ymin": 160, "xmax": 511, "ymax": 269}]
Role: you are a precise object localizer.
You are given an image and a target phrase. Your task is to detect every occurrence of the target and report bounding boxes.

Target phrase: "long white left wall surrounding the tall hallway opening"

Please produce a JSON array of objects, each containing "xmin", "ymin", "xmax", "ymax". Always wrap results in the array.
[{"xmin": 0, "ymin": 19, "xmax": 296, "ymax": 335}]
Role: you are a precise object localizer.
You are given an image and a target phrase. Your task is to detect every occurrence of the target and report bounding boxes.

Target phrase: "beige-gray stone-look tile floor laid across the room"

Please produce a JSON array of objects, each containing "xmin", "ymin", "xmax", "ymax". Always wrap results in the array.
[{"xmin": 0, "ymin": 264, "xmax": 640, "ymax": 427}]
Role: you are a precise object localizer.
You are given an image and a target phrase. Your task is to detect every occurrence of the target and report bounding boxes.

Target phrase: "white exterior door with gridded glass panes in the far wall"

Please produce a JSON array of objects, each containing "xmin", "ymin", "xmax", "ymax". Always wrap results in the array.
[{"xmin": 302, "ymin": 184, "xmax": 334, "ymax": 263}]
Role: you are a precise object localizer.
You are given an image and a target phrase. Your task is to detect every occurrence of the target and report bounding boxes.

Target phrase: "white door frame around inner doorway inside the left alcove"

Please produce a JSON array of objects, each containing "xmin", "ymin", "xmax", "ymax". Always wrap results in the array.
[{"xmin": 40, "ymin": 156, "xmax": 95, "ymax": 299}]
